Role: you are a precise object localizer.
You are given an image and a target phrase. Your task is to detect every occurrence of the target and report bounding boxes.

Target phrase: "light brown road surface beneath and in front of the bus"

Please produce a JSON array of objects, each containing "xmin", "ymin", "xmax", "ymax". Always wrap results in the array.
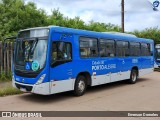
[{"xmin": 0, "ymin": 72, "xmax": 160, "ymax": 120}]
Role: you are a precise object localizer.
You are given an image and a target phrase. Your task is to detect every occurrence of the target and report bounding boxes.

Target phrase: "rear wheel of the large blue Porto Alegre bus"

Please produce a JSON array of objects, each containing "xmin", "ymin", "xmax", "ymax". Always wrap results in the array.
[{"xmin": 128, "ymin": 69, "xmax": 138, "ymax": 84}]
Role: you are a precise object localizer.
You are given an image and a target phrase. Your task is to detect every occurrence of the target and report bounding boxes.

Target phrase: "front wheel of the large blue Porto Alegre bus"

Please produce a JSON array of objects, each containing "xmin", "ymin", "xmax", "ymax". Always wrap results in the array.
[{"xmin": 74, "ymin": 76, "xmax": 87, "ymax": 96}]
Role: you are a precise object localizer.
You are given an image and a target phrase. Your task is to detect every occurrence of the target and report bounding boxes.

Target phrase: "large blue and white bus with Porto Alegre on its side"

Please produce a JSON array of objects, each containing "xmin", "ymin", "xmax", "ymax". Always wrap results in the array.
[{"xmin": 12, "ymin": 26, "xmax": 154, "ymax": 96}]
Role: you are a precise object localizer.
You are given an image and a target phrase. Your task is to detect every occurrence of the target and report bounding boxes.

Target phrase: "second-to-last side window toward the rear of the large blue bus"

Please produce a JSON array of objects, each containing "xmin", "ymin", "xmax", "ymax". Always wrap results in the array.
[{"xmin": 130, "ymin": 42, "xmax": 141, "ymax": 56}]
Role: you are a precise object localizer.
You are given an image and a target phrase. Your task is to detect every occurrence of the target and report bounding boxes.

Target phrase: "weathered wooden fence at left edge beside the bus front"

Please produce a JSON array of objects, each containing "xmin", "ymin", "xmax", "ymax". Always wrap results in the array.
[{"xmin": 0, "ymin": 41, "xmax": 14, "ymax": 74}]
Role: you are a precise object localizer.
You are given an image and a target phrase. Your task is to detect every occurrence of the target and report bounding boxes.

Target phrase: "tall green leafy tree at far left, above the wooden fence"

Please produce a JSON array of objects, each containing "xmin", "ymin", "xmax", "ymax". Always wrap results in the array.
[{"xmin": 0, "ymin": 0, "xmax": 47, "ymax": 39}]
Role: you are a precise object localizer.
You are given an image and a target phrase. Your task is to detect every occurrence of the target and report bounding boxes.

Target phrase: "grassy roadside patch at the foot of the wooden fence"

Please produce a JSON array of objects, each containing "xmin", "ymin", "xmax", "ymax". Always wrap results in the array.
[{"xmin": 0, "ymin": 80, "xmax": 22, "ymax": 97}]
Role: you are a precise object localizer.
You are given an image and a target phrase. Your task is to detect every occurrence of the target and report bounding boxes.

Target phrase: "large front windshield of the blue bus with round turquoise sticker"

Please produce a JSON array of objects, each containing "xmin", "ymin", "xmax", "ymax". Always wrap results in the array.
[{"xmin": 15, "ymin": 38, "xmax": 47, "ymax": 71}]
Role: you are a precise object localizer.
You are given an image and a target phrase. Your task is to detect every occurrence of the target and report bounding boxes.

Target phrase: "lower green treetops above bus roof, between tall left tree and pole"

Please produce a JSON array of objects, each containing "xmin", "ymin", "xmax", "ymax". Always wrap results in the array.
[{"xmin": 47, "ymin": 9, "xmax": 121, "ymax": 32}]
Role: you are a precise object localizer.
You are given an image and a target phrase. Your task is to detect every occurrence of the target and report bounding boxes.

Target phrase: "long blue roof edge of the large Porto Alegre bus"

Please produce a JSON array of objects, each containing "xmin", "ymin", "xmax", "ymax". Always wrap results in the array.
[{"xmin": 20, "ymin": 25, "xmax": 153, "ymax": 43}]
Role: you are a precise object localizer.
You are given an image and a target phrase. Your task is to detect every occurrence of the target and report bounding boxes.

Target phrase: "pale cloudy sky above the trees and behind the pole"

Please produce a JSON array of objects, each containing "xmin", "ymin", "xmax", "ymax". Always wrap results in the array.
[{"xmin": 25, "ymin": 0, "xmax": 160, "ymax": 31}]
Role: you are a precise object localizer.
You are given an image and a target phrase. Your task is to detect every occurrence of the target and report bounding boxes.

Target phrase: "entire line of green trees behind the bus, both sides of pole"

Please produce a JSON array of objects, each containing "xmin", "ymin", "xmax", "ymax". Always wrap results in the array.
[{"xmin": 0, "ymin": 0, "xmax": 160, "ymax": 44}]
